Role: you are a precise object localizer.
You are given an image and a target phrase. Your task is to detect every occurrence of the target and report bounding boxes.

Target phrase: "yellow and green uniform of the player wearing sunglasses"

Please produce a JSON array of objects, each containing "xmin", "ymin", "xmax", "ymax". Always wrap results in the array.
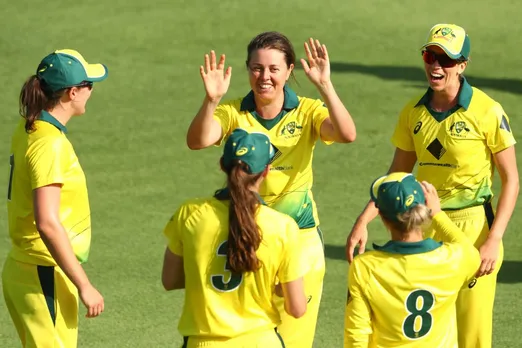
[{"xmin": 392, "ymin": 79, "xmax": 515, "ymax": 348}]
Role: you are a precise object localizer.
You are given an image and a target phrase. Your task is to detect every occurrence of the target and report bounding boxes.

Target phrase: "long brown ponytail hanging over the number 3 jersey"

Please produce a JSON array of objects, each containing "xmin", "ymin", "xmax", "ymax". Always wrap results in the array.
[{"xmin": 219, "ymin": 160, "xmax": 262, "ymax": 273}]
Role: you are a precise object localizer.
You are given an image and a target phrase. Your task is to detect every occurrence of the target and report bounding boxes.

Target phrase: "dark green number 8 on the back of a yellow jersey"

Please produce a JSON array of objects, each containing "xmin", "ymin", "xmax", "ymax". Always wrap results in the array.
[{"xmin": 402, "ymin": 290, "xmax": 435, "ymax": 340}]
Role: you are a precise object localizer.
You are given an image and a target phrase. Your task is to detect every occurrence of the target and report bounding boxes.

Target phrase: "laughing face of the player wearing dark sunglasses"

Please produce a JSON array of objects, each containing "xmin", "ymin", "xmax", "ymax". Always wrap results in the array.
[{"xmin": 423, "ymin": 45, "xmax": 468, "ymax": 92}]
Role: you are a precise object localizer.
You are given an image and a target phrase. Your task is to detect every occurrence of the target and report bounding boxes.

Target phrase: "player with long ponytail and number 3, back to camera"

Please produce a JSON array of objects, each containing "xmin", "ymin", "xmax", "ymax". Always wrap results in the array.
[{"xmin": 162, "ymin": 129, "xmax": 307, "ymax": 348}]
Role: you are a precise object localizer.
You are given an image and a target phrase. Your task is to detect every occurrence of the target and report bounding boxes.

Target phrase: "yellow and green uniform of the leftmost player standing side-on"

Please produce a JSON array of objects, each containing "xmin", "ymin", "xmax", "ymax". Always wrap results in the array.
[{"xmin": 2, "ymin": 111, "xmax": 91, "ymax": 347}]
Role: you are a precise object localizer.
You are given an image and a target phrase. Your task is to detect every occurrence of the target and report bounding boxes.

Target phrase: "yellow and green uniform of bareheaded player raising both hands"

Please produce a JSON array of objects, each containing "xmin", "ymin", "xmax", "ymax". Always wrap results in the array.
[{"xmin": 214, "ymin": 86, "xmax": 330, "ymax": 348}]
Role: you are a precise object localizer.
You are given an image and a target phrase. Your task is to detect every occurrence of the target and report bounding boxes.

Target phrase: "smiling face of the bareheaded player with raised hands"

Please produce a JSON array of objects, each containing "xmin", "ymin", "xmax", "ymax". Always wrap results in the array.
[{"xmin": 248, "ymin": 48, "xmax": 294, "ymax": 102}]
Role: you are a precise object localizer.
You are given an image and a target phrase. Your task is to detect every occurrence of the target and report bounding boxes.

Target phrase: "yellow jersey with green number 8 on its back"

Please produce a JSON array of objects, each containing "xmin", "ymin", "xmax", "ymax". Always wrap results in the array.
[{"xmin": 344, "ymin": 213, "xmax": 480, "ymax": 348}]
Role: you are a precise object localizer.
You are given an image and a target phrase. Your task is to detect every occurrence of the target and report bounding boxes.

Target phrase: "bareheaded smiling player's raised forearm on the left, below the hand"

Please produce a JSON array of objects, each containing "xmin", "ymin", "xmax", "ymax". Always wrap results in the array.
[{"xmin": 187, "ymin": 97, "xmax": 221, "ymax": 150}]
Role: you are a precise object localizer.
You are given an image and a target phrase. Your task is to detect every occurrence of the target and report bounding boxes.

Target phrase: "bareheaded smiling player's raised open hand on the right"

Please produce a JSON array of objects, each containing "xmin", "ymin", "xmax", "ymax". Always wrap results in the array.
[{"xmin": 301, "ymin": 38, "xmax": 330, "ymax": 86}]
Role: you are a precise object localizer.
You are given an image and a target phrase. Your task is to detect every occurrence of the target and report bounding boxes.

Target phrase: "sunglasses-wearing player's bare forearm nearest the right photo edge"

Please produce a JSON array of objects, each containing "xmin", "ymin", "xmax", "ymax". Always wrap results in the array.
[{"xmin": 488, "ymin": 175, "xmax": 520, "ymax": 240}]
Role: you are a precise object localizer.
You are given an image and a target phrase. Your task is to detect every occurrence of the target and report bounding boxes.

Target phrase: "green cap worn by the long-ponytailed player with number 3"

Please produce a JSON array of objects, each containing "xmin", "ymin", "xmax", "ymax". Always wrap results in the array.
[{"xmin": 223, "ymin": 128, "xmax": 275, "ymax": 174}]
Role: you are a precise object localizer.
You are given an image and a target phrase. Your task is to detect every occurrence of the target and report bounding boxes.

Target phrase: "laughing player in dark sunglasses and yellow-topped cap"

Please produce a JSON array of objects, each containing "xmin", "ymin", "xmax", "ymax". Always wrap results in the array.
[{"xmin": 347, "ymin": 24, "xmax": 519, "ymax": 348}]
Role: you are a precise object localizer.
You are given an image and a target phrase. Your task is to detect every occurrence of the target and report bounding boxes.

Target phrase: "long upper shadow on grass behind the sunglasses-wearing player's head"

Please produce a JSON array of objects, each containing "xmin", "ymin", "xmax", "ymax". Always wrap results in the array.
[{"xmin": 296, "ymin": 62, "xmax": 522, "ymax": 94}]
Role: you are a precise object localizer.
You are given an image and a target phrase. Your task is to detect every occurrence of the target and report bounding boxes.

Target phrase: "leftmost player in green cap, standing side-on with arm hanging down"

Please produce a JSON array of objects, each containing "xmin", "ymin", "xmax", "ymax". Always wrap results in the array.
[{"xmin": 2, "ymin": 49, "xmax": 108, "ymax": 348}]
